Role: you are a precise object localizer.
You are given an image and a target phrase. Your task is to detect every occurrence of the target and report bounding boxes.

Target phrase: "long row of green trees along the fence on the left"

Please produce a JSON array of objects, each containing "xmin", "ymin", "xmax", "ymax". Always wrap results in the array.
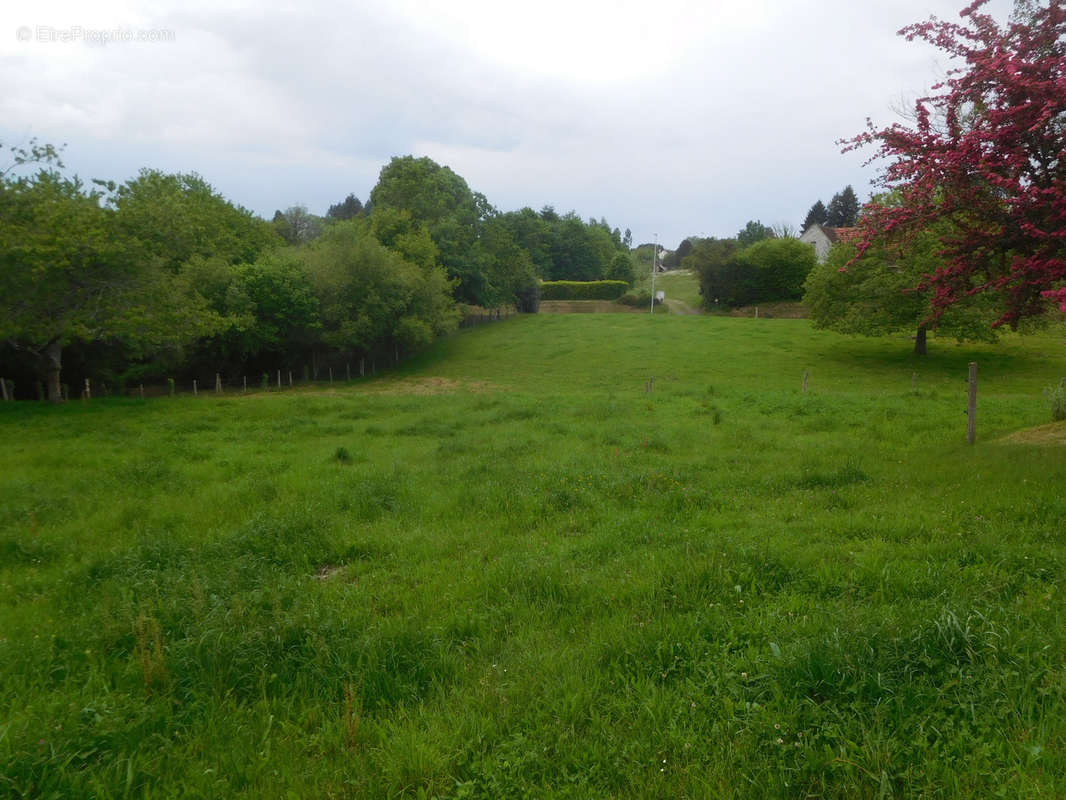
[{"xmin": 0, "ymin": 150, "xmax": 634, "ymax": 401}]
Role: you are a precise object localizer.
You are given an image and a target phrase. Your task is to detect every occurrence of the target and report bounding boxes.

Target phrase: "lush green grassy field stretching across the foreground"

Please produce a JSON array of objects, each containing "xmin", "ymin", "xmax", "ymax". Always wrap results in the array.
[{"xmin": 0, "ymin": 315, "xmax": 1066, "ymax": 798}]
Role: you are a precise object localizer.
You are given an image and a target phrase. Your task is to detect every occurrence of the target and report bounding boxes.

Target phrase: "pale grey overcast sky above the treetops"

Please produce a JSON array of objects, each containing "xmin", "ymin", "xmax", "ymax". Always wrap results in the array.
[{"xmin": 0, "ymin": 0, "xmax": 1011, "ymax": 247}]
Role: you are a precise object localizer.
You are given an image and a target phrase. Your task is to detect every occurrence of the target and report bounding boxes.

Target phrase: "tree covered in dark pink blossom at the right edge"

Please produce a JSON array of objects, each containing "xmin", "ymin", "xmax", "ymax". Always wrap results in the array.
[{"xmin": 841, "ymin": 0, "xmax": 1066, "ymax": 326}]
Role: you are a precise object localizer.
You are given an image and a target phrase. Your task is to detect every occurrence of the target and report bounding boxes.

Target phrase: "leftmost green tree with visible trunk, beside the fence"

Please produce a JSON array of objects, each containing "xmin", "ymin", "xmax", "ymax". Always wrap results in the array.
[{"xmin": 0, "ymin": 170, "xmax": 221, "ymax": 402}]
